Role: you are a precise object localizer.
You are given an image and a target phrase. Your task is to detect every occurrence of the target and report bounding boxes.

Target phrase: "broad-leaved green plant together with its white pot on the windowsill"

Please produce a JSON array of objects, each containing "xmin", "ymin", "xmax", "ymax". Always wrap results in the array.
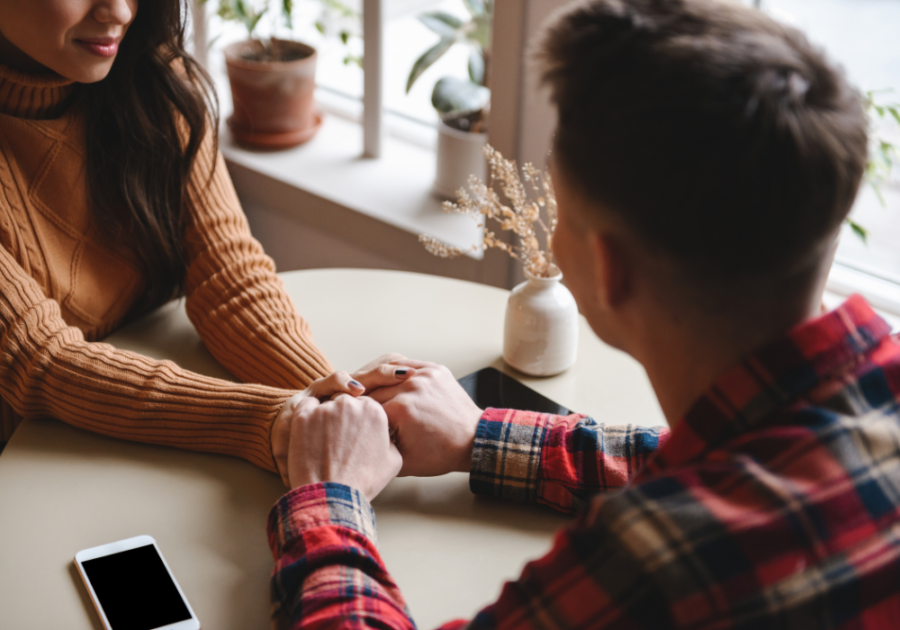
[{"xmin": 406, "ymin": 0, "xmax": 494, "ymax": 199}]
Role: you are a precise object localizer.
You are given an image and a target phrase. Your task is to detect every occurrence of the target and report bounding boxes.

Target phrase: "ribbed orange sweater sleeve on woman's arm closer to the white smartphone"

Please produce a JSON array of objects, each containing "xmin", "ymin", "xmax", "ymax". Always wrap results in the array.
[{"xmin": 0, "ymin": 247, "xmax": 293, "ymax": 471}]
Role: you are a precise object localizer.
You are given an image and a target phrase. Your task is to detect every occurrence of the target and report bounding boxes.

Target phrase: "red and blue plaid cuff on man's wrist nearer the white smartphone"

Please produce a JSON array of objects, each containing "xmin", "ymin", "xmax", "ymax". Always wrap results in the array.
[{"xmin": 268, "ymin": 481, "xmax": 376, "ymax": 560}]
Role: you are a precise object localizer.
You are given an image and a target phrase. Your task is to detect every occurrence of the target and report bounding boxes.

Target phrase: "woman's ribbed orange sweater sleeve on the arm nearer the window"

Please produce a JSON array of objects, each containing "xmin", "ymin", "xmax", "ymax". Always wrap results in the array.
[{"xmin": 186, "ymin": 128, "xmax": 333, "ymax": 389}]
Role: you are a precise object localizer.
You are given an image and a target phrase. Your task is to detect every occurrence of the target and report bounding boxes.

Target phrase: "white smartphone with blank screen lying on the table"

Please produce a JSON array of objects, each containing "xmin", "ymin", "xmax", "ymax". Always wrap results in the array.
[{"xmin": 75, "ymin": 536, "xmax": 200, "ymax": 630}]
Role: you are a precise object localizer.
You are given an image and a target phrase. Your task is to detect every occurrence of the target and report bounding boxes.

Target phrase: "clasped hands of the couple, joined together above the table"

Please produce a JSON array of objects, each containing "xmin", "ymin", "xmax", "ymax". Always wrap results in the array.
[{"xmin": 272, "ymin": 355, "xmax": 482, "ymax": 500}]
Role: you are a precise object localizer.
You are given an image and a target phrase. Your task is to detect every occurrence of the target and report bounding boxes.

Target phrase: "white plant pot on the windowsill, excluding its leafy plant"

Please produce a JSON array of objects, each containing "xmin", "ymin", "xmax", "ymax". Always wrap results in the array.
[{"xmin": 434, "ymin": 122, "xmax": 487, "ymax": 199}]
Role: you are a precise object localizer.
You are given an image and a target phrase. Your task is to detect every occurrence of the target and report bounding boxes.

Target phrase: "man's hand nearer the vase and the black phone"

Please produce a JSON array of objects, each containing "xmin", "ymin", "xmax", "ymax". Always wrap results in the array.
[{"xmin": 369, "ymin": 359, "xmax": 482, "ymax": 477}]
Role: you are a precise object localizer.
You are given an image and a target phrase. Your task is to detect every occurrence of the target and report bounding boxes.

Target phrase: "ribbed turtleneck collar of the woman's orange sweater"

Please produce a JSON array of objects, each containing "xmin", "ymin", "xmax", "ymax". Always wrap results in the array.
[{"xmin": 0, "ymin": 64, "xmax": 75, "ymax": 119}]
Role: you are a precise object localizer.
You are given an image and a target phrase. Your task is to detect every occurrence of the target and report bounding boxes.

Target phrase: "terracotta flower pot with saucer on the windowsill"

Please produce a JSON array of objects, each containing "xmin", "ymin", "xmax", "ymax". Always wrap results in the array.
[{"xmin": 224, "ymin": 39, "xmax": 322, "ymax": 148}]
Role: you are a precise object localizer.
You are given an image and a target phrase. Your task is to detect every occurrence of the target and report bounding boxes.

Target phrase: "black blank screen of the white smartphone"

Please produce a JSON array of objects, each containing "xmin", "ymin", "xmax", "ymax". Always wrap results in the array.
[{"xmin": 81, "ymin": 545, "xmax": 191, "ymax": 630}]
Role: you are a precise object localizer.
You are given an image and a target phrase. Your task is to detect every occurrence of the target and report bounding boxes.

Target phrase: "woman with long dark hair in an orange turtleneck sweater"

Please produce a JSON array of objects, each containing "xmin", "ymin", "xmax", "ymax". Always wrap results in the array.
[{"xmin": 0, "ymin": 0, "xmax": 380, "ymax": 484}]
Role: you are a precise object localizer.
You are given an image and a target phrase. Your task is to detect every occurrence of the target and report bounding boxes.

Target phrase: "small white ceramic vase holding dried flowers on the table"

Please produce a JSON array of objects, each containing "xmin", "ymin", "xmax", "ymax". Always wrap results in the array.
[{"xmin": 503, "ymin": 265, "xmax": 578, "ymax": 376}]
